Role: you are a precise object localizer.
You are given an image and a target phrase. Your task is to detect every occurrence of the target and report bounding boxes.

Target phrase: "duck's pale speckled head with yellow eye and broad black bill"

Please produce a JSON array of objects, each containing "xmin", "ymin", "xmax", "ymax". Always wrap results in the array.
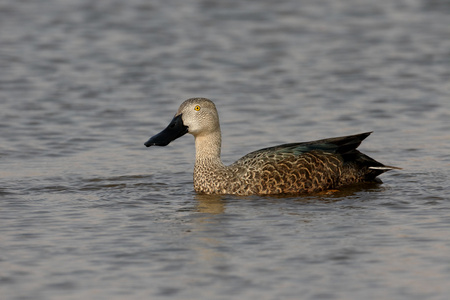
[{"xmin": 145, "ymin": 98, "xmax": 220, "ymax": 147}]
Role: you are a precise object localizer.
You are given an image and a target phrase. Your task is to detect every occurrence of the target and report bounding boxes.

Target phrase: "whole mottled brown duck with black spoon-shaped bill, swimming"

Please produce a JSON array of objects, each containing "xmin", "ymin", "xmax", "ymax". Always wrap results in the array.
[{"xmin": 145, "ymin": 98, "xmax": 397, "ymax": 195}]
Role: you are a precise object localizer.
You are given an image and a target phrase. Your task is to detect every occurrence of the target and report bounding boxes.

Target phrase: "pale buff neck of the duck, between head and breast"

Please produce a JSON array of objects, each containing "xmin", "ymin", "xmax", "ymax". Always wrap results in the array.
[{"xmin": 195, "ymin": 130, "xmax": 223, "ymax": 166}]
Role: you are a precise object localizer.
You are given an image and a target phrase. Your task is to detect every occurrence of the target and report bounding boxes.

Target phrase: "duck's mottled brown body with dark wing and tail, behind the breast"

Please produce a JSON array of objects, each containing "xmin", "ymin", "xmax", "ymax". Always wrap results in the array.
[{"xmin": 229, "ymin": 132, "xmax": 390, "ymax": 194}]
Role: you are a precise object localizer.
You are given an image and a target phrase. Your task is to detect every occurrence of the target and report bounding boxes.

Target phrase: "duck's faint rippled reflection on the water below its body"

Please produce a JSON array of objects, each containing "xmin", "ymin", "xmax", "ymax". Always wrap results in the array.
[{"xmin": 189, "ymin": 183, "xmax": 383, "ymax": 264}]
